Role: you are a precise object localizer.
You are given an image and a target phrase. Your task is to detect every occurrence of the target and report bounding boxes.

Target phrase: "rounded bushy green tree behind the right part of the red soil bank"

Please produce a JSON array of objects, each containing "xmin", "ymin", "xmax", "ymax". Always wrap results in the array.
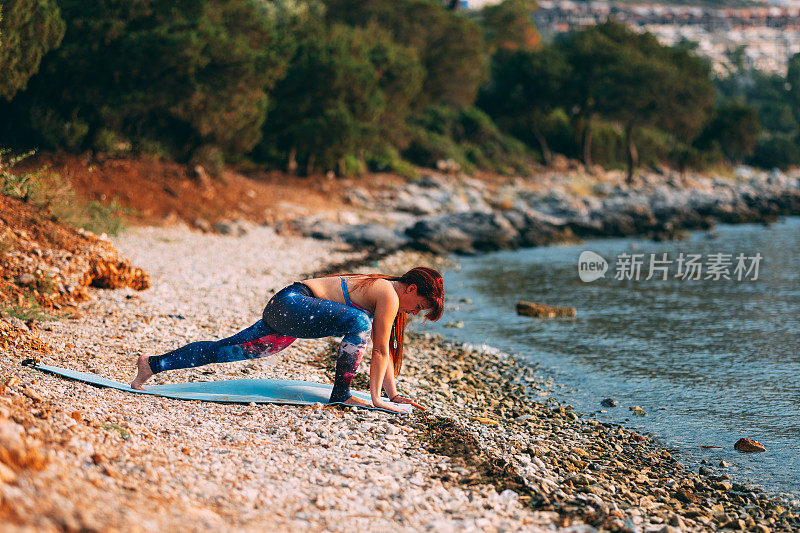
[{"xmin": 256, "ymin": 24, "xmax": 423, "ymax": 174}]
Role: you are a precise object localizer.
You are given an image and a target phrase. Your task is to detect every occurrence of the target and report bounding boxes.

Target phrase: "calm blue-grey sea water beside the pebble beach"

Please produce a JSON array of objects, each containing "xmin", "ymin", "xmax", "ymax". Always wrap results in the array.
[{"xmin": 415, "ymin": 218, "xmax": 800, "ymax": 498}]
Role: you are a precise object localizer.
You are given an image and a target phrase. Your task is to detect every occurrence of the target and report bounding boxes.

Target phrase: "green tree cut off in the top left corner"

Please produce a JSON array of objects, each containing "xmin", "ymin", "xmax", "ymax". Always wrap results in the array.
[{"xmin": 0, "ymin": 0, "xmax": 64, "ymax": 100}]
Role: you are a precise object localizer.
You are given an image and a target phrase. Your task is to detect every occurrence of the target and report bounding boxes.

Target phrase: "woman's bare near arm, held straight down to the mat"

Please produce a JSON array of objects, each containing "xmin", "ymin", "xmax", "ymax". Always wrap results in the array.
[{"xmin": 369, "ymin": 282, "xmax": 400, "ymax": 411}]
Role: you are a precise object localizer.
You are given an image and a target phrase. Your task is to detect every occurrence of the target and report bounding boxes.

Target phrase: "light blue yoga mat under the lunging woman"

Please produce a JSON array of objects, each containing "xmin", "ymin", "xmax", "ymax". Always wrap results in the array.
[{"xmin": 33, "ymin": 365, "xmax": 412, "ymax": 413}]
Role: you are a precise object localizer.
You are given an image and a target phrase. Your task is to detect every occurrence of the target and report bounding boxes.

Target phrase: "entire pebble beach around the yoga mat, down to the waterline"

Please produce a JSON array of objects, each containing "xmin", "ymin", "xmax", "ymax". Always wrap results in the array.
[{"xmin": 0, "ymin": 222, "xmax": 800, "ymax": 532}]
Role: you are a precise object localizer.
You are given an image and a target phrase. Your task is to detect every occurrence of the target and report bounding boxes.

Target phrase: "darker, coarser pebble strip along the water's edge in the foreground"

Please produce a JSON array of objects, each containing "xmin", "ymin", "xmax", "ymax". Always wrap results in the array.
[{"xmin": 400, "ymin": 334, "xmax": 800, "ymax": 531}]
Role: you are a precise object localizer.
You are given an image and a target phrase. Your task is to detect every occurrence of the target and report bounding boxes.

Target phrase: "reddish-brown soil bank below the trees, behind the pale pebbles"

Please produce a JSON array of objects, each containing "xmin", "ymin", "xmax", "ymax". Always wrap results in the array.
[{"xmin": 20, "ymin": 154, "xmax": 412, "ymax": 229}]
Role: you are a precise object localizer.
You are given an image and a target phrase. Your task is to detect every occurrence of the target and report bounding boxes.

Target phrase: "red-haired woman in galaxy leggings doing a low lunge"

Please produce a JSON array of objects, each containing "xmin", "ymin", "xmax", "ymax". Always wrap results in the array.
[{"xmin": 131, "ymin": 267, "xmax": 444, "ymax": 411}]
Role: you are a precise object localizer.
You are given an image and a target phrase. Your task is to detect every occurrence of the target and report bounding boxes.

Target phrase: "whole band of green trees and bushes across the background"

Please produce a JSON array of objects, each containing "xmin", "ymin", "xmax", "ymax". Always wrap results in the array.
[{"xmin": 0, "ymin": 0, "xmax": 800, "ymax": 178}]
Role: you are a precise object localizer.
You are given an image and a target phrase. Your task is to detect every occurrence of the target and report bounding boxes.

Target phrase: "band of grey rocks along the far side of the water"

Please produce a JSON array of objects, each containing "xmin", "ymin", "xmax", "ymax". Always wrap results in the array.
[{"xmin": 284, "ymin": 167, "xmax": 800, "ymax": 253}]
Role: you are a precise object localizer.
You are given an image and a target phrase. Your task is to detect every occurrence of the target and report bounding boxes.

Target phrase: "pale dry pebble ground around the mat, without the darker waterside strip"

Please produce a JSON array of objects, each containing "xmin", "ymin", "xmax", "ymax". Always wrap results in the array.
[{"xmin": 0, "ymin": 227, "xmax": 548, "ymax": 531}]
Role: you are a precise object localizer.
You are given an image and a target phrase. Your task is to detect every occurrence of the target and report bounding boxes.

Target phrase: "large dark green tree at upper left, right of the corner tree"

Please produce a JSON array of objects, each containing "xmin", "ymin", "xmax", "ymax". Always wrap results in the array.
[{"xmin": 0, "ymin": 0, "xmax": 292, "ymax": 162}]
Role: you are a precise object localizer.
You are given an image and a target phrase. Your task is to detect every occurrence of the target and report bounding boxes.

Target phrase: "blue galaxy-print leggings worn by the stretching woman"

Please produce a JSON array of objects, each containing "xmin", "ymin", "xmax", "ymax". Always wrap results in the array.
[{"xmin": 149, "ymin": 282, "xmax": 372, "ymax": 403}]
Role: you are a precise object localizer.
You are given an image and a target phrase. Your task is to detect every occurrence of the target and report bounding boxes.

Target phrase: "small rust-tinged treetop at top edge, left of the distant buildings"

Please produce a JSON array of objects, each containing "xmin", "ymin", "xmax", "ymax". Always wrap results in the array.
[{"xmin": 481, "ymin": 0, "xmax": 541, "ymax": 54}]
